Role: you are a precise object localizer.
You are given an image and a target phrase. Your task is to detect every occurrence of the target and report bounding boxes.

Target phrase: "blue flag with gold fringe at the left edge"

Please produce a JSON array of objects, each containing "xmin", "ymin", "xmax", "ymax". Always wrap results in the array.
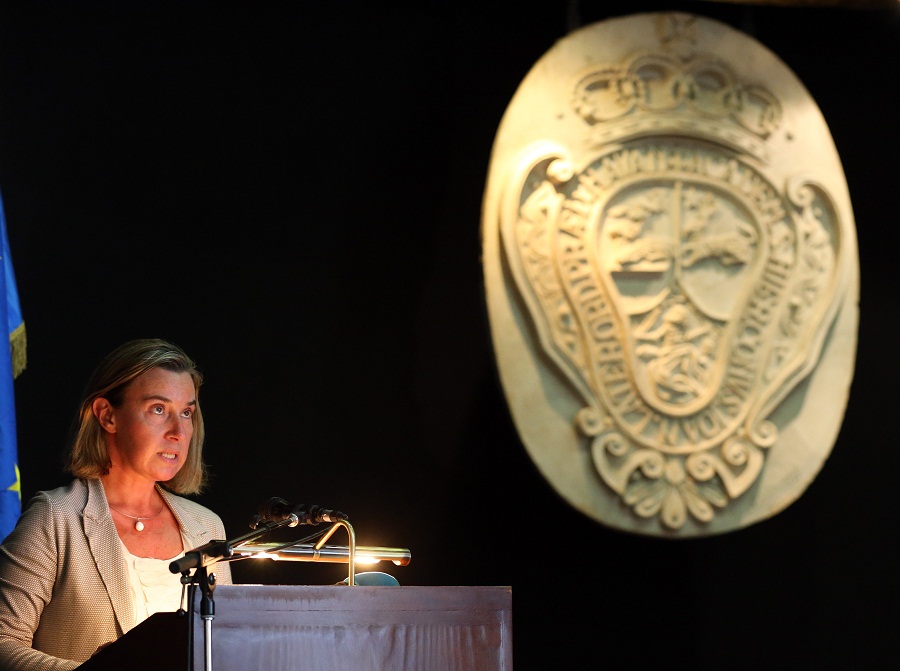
[{"xmin": 0, "ymin": 193, "xmax": 25, "ymax": 540}]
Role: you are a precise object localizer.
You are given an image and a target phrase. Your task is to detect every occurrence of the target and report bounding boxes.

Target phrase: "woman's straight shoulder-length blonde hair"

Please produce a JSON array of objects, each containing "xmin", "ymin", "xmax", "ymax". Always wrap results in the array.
[{"xmin": 66, "ymin": 338, "xmax": 207, "ymax": 494}]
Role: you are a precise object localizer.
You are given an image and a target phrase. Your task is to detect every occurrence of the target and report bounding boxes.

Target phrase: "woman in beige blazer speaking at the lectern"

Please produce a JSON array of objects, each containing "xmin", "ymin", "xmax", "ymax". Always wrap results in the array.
[{"xmin": 0, "ymin": 339, "xmax": 231, "ymax": 671}]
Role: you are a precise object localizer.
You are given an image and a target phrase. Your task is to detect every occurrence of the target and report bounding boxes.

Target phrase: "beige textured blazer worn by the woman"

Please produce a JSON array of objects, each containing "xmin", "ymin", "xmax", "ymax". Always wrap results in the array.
[{"xmin": 0, "ymin": 480, "xmax": 231, "ymax": 671}]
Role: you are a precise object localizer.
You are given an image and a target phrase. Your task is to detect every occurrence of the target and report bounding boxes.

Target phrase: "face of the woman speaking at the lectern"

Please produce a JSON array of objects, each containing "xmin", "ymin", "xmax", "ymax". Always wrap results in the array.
[{"xmin": 98, "ymin": 368, "xmax": 197, "ymax": 482}]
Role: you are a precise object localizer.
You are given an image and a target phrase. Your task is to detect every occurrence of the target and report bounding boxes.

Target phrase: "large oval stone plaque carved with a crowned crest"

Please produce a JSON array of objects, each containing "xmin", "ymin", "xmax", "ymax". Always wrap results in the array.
[{"xmin": 482, "ymin": 13, "xmax": 859, "ymax": 537}]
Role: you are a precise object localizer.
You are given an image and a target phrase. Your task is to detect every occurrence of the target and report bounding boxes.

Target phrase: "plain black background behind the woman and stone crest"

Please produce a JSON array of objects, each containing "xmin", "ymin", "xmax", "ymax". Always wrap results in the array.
[{"xmin": 0, "ymin": 0, "xmax": 900, "ymax": 671}]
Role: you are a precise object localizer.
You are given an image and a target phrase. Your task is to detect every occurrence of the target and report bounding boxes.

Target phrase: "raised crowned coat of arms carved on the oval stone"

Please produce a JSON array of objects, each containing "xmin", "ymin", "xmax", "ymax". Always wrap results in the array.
[{"xmin": 501, "ymin": 31, "xmax": 841, "ymax": 529}]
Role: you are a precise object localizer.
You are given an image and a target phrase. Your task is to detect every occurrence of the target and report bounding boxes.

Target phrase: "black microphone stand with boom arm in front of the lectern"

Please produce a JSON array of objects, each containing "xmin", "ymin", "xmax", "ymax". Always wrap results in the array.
[{"xmin": 169, "ymin": 515, "xmax": 300, "ymax": 671}]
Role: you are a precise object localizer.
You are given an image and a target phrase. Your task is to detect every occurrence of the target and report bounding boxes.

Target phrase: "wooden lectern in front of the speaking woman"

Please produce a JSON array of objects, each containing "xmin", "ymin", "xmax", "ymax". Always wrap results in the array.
[{"xmin": 79, "ymin": 585, "xmax": 512, "ymax": 671}]
